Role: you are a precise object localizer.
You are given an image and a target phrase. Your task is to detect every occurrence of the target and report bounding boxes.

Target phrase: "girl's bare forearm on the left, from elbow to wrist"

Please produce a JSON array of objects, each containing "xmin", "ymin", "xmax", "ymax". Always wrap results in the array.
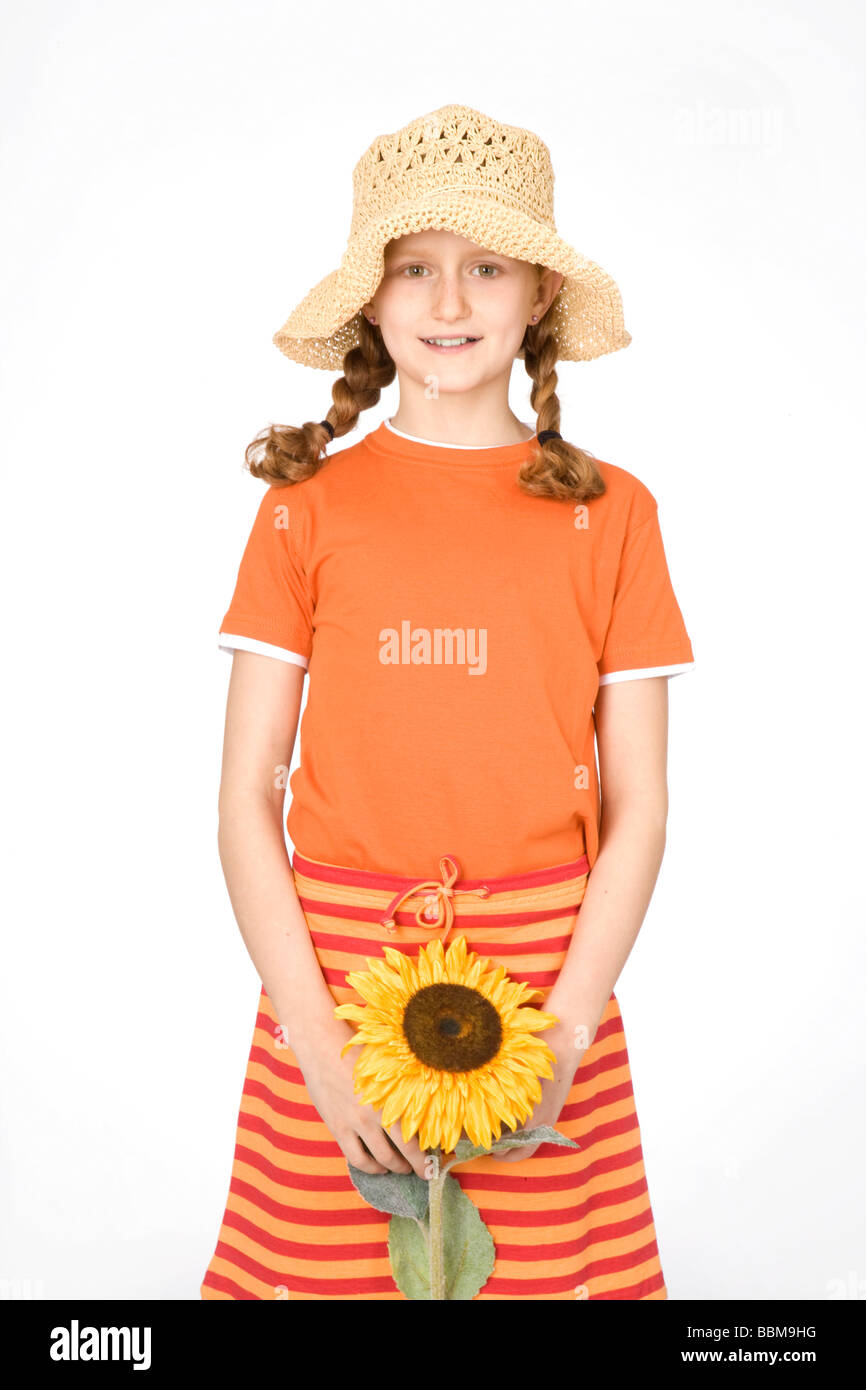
[{"xmin": 218, "ymin": 792, "xmax": 339, "ymax": 1045}]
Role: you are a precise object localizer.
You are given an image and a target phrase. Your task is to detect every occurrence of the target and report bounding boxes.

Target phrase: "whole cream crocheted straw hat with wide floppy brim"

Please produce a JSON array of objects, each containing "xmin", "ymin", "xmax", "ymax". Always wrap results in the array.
[{"xmin": 272, "ymin": 106, "xmax": 631, "ymax": 371}]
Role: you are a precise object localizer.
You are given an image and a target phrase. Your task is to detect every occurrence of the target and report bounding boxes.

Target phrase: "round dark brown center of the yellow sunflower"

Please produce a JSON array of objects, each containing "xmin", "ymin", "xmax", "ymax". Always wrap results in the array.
[{"xmin": 403, "ymin": 983, "xmax": 502, "ymax": 1072}]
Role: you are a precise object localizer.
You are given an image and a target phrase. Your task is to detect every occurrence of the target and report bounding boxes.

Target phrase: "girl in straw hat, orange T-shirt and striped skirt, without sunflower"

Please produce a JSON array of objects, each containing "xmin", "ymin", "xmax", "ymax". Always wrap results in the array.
[{"xmin": 200, "ymin": 106, "xmax": 694, "ymax": 1300}]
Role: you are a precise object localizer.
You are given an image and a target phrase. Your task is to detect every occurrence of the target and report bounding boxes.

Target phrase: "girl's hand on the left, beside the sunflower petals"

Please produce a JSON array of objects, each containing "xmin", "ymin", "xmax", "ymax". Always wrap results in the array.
[{"xmin": 289, "ymin": 1019, "xmax": 427, "ymax": 1177}]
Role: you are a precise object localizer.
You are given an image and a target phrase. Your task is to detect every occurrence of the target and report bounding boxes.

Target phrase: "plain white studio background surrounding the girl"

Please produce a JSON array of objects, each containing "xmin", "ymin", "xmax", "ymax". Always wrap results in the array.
[{"xmin": 0, "ymin": 0, "xmax": 866, "ymax": 1300}]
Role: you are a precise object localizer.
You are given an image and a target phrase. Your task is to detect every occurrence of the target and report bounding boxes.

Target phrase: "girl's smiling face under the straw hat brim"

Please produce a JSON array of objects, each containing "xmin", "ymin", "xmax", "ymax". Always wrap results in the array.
[{"xmin": 363, "ymin": 231, "xmax": 563, "ymax": 391}]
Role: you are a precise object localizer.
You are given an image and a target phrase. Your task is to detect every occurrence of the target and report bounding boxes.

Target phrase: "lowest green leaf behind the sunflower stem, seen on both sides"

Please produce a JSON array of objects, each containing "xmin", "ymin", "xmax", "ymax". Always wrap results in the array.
[{"xmin": 388, "ymin": 1175, "xmax": 496, "ymax": 1302}]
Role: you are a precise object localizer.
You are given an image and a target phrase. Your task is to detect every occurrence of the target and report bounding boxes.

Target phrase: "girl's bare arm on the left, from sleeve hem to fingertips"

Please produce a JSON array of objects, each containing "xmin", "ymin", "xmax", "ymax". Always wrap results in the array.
[{"xmin": 218, "ymin": 651, "xmax": 424, "ymax": 1175}]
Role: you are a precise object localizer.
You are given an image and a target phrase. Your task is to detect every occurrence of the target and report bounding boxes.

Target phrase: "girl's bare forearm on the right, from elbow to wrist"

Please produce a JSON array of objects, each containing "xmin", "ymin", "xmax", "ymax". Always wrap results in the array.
[{"xmin": 553, "ymin": 805, "xmax": 666, "ymax": 1052}]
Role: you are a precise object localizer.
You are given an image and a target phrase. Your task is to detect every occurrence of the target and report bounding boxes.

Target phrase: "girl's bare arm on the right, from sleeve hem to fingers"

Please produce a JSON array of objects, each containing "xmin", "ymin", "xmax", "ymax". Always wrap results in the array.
[{"xmin": 500, "ymin": 676, "xmax": 667, "ymax": 1162}]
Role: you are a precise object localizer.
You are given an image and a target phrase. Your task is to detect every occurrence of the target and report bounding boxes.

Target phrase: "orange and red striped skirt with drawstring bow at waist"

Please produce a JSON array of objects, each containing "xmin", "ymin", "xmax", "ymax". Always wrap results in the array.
[{"xmin": 200, "ymin": 852, "xmax": 667, "ymax": 1301}]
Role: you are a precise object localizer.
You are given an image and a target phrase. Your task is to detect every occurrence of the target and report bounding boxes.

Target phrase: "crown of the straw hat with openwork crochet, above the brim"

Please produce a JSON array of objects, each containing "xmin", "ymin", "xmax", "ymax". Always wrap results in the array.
[{"xmin": 352, "ymin": 104, "xmax": 556, "ymax": 236}]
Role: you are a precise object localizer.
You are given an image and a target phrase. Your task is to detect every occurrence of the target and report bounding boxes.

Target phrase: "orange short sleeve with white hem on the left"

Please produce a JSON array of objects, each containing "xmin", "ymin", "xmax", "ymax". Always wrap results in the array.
[{"xmin": 218, "ymin": 487, "xmax": 314, "ymax": 669}]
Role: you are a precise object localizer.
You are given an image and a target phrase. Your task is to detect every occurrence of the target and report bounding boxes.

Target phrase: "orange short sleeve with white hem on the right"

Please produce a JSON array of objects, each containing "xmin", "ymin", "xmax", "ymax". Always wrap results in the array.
[{"xmin": 598, "ymin": 500, "xmax": 695, "ymax": 685}]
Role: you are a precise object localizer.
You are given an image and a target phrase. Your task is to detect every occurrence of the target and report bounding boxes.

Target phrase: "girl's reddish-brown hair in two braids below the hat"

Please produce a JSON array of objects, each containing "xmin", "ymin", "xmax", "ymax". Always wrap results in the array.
[{"xmin": 245, "ymin": 265, "xmax": 605, "ymax": 502}]
